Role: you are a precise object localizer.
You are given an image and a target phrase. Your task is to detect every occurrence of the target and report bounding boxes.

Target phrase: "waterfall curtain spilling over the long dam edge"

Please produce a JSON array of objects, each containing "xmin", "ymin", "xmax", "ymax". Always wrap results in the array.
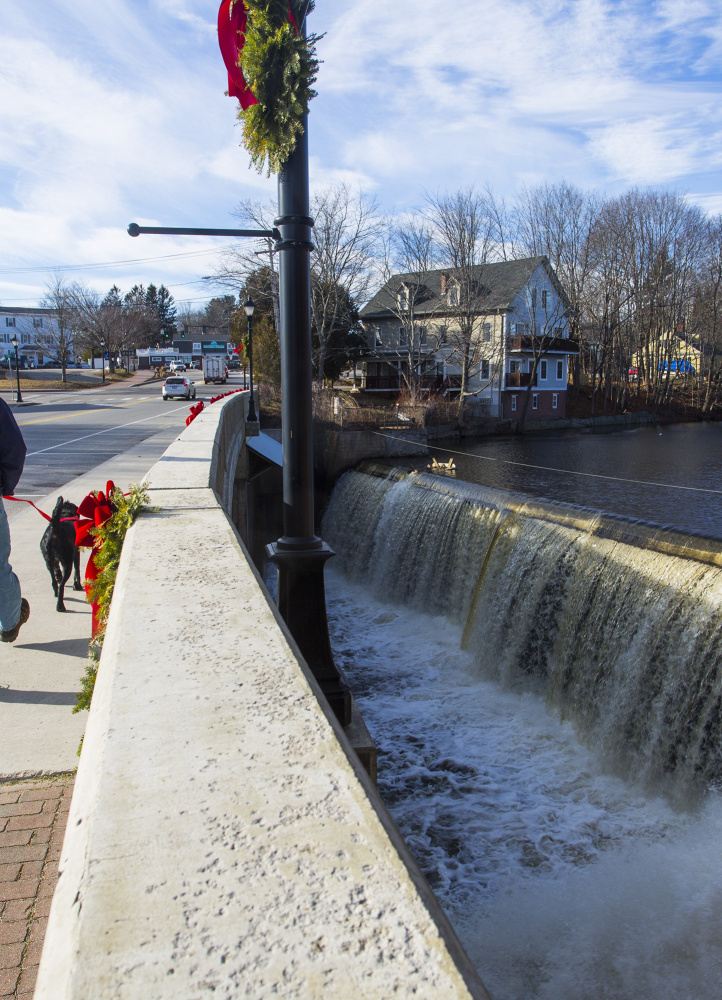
[{"xmin": 323, "ymin": 463, "xmax": 722, "ymax": 787}]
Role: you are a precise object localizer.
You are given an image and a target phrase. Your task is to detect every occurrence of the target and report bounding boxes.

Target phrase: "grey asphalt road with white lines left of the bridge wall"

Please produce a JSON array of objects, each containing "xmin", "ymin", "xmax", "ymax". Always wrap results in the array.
[{"xmin": 3, "ymin": 371, "xmax": 248, "ymax": 504}]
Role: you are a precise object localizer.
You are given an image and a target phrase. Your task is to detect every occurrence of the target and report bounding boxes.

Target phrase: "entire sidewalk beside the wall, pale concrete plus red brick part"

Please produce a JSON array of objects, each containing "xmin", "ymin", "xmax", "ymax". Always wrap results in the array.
[{"xmin": 0, "ymin": 427, "xmax": 181, "ymax": 998}]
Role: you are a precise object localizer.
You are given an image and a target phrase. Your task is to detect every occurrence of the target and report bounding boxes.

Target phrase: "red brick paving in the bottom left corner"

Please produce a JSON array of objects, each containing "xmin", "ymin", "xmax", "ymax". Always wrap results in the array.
[{"xmin": 0, "ymin": 776, "xmax": 74, "ymax": 998}]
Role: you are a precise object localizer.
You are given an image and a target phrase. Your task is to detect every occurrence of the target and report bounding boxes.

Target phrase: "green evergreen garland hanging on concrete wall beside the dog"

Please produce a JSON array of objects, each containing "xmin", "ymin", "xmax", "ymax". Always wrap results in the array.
[{"xmin": 73, "ymin": 483, "xmax": 148, "ymax": 712}]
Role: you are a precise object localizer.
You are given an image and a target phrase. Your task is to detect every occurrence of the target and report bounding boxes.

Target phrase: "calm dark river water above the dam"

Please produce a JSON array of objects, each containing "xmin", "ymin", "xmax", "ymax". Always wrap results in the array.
[{"xmin": 428, "ymin": 423, "xmax": 722, "ymax": 538}]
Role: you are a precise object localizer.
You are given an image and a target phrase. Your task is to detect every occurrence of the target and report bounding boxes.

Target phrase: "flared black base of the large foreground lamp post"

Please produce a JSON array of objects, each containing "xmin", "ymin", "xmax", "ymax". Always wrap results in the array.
[{"xmin": 266, "ymin": 538, "xmax": 352, "ymax": 726}]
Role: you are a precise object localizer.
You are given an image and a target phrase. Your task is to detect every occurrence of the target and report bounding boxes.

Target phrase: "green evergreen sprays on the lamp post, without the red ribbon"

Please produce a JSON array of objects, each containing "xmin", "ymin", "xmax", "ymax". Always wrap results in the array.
[{"xmin": 236, "ymin": 0, "xmax": 322, "ymax": 176}]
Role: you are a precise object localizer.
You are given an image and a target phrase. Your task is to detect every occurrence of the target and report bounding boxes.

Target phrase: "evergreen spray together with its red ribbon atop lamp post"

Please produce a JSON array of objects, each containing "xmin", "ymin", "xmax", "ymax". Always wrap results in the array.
[{"xmin": 218, "ymin": 0, "xmax": 321, "ymax": 175}]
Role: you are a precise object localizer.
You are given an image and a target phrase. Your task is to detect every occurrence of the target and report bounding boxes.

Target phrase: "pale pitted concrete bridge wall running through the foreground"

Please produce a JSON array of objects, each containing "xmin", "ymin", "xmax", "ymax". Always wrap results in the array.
[{"xmin": 35, "ymin": 394, "xmax": 486, "ymax": 1000}]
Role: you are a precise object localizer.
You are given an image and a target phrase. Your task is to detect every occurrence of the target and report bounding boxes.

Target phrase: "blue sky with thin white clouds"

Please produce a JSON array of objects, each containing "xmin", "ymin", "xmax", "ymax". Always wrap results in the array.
[{"xmin": 0, "ymin": 0, "xmax": 722, "ymax": 306}]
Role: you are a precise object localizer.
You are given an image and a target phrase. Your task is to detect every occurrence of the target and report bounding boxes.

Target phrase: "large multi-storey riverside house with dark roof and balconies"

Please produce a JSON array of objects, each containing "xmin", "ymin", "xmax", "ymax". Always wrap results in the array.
[{"xmin": 356, "ymin": 257, "xmax": 578, "ymax": 419}]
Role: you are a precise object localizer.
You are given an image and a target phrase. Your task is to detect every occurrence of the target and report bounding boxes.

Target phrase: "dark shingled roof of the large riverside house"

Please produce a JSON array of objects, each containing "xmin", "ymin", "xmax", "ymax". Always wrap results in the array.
[{"xmin": 360, "ymin": 257, "xmax": 568, "ymax": 319}]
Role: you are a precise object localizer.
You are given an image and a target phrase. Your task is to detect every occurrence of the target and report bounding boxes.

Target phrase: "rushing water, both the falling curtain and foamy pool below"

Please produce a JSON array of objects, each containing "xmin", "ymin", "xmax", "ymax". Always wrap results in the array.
[{"xmin": 324, "ymin": 473, "xmax": 722, "ymax": 1000}]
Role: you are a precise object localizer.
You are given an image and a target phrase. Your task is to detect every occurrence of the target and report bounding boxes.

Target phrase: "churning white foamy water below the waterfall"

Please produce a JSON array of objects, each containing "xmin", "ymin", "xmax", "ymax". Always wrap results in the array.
[{"xmin": 327, "ymin": 566, "xmax": 722, "ymax": 1000}]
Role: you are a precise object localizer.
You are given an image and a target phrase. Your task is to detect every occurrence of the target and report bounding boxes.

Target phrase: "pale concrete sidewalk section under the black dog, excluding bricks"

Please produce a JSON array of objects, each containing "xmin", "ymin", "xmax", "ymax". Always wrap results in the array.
[{"xmin": 0, "ymin": 428, "xmax": 184, "ymax": 781}]
